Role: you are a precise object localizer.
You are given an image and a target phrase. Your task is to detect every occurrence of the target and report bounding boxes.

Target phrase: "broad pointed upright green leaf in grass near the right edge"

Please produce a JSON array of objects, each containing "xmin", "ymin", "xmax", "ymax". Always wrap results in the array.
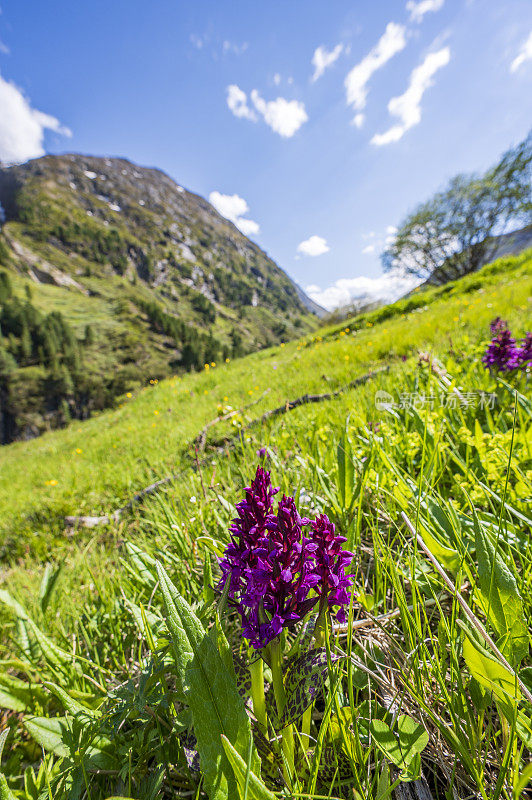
[{"xmin": 473, "ymin": 510, "xmax": 529, "ymax": 667}]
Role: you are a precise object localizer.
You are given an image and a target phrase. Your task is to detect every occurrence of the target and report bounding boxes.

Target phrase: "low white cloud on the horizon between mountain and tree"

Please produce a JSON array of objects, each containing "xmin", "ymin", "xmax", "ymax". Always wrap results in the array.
[{"xmin": 305, "ymin": 272, "xmax": 420, "ymax": 311}]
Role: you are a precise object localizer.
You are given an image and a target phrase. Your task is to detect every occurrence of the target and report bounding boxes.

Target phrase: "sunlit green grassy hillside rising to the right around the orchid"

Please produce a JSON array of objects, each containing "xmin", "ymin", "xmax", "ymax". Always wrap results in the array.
[{"xmin": 0, "ymin": 251, "xmax": 532, "ymax": 800}]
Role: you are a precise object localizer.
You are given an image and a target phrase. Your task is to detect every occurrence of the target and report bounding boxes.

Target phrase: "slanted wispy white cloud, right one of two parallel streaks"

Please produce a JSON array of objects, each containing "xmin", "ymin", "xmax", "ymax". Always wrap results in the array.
[{"xmin": 371, "ymin": 47, "xmax": 451, "ymax": 146}]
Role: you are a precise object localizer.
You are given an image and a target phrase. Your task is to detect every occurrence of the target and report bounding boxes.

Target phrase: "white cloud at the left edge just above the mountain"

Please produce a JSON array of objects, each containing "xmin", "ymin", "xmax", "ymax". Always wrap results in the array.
[{"xmin": 0, "ymin": 75, "xmax": 72, "ymax": 164}]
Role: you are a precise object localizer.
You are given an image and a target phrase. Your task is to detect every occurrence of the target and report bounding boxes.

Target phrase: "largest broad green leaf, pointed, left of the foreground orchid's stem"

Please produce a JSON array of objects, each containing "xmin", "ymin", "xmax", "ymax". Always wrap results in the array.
[{"xmin": 157, "ymin": 563, "xmax": 260, "ymax": 800}]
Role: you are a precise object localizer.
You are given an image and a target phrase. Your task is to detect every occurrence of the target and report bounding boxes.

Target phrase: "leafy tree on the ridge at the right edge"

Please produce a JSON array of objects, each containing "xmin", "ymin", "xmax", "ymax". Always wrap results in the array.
[{"xmin": 381, "ymin": 133, "xmax": 532, "ymax": 283}]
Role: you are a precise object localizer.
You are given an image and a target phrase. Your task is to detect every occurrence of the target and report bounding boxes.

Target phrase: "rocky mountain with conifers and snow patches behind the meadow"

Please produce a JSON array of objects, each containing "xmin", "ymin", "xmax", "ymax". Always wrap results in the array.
[{"xmin": 0, "ymin": 154, "xmax": 320, "ymax": 442}]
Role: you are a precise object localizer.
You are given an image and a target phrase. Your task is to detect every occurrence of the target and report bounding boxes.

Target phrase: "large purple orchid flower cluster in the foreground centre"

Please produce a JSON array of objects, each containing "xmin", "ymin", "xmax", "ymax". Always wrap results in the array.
[{"xmin": 218, "ymin": 467, "xmax": 353, "ymax": 649}]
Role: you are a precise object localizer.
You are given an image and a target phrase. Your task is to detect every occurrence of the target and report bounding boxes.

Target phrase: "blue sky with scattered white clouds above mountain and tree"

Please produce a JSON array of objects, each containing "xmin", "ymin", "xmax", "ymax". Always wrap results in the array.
[{"xmin": 0, "ymin": 0, "xmax": 532, "ymax": 306}]
